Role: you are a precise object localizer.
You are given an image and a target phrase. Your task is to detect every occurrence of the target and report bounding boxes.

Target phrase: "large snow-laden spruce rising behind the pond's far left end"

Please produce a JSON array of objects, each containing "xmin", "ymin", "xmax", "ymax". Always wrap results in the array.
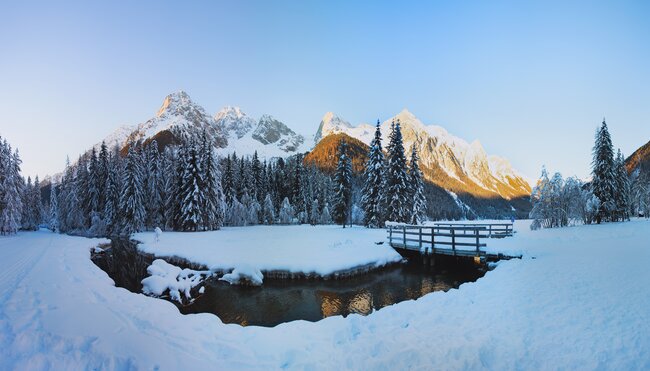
[{"xmin": 119, "ymin": 146, "xmax": 146, "ymax": 235}]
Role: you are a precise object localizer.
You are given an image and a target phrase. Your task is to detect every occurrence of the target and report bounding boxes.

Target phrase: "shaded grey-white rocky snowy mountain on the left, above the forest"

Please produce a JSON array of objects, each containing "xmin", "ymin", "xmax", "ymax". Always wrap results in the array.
[{"xmin": 104, "ymin": 91, "xmax": 309, "ymax": 157}]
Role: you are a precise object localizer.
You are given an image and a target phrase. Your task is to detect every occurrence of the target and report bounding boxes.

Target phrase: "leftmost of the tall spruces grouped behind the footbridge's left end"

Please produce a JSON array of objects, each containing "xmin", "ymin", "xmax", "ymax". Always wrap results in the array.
[{"xmin": 361, "ymin": 120, "xmax": 384, "ymax": 228}]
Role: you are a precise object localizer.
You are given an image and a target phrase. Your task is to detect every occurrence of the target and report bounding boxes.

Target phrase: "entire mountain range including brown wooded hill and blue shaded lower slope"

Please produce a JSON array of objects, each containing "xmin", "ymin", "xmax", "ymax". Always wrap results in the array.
[{"xmin": 96, "ymin": 91, "xmax": 531, "ymax": 219}]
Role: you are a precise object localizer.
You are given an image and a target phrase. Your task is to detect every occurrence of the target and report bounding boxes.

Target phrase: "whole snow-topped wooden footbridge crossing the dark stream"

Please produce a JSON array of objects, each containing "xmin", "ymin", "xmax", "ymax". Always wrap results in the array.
[{"xmin": 387, "ymin": 223, "xmax": 513, "ymax": 263}]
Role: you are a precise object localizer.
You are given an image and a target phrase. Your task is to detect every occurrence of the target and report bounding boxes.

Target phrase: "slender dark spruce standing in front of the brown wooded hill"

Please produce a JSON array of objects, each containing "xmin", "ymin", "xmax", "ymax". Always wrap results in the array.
[{"xmin": 332, "ymin": 140, "xmax": 352, "ymax": 228}]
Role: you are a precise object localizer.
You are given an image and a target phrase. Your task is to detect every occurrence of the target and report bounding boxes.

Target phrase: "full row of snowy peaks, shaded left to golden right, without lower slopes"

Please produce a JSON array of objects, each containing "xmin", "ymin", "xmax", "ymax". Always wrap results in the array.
[{"xmin": 91, "ymin": 91, "xmax": 530, "ymax": 199}]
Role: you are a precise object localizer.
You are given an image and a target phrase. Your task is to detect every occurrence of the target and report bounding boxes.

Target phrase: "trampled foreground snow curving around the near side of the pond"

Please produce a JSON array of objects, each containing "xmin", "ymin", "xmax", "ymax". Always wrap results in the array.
[{"xmin": 0, "ymin": 220, "xmax": 650, "ymax": 370}]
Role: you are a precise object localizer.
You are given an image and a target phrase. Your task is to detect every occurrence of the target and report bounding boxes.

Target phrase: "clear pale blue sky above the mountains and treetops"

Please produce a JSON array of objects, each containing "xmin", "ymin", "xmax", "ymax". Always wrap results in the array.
[{"xmin": 0, "ymin": 1, "xmax": 650, "ymax": 178}]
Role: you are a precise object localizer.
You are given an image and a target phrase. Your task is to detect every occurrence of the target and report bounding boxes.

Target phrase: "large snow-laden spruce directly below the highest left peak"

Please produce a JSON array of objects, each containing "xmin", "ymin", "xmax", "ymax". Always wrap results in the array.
[{"xmin": 178, "ymin": 141, "xmax": 206, "ymax": 231}]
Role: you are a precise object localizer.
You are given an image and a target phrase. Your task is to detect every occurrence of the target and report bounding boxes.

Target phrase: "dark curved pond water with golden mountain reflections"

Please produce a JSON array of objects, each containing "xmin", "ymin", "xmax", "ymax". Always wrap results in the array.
[{"xmin": 93, "ymin": 241, "xmax": 485, "ymax": 326}]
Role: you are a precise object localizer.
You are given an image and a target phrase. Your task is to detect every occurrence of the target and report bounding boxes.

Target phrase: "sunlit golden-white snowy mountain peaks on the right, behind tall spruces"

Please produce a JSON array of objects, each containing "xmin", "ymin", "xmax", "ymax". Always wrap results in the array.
[{"xmin": 314, "ymin": 109, "xmax": 530, "ymax": 199}]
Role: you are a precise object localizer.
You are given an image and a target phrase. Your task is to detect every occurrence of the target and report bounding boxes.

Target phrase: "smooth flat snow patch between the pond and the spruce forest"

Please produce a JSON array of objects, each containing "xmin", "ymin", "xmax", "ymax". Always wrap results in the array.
[{"xmin": 133, "ymin": 225, "xmax": 402, "ymax": 276}]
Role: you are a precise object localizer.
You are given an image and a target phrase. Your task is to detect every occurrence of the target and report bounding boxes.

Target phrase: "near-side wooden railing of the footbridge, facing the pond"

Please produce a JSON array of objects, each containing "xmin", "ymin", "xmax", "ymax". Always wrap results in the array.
[{"xmin": 386, "ymin": 224, "xmax": 487, "ymax": 256}]
